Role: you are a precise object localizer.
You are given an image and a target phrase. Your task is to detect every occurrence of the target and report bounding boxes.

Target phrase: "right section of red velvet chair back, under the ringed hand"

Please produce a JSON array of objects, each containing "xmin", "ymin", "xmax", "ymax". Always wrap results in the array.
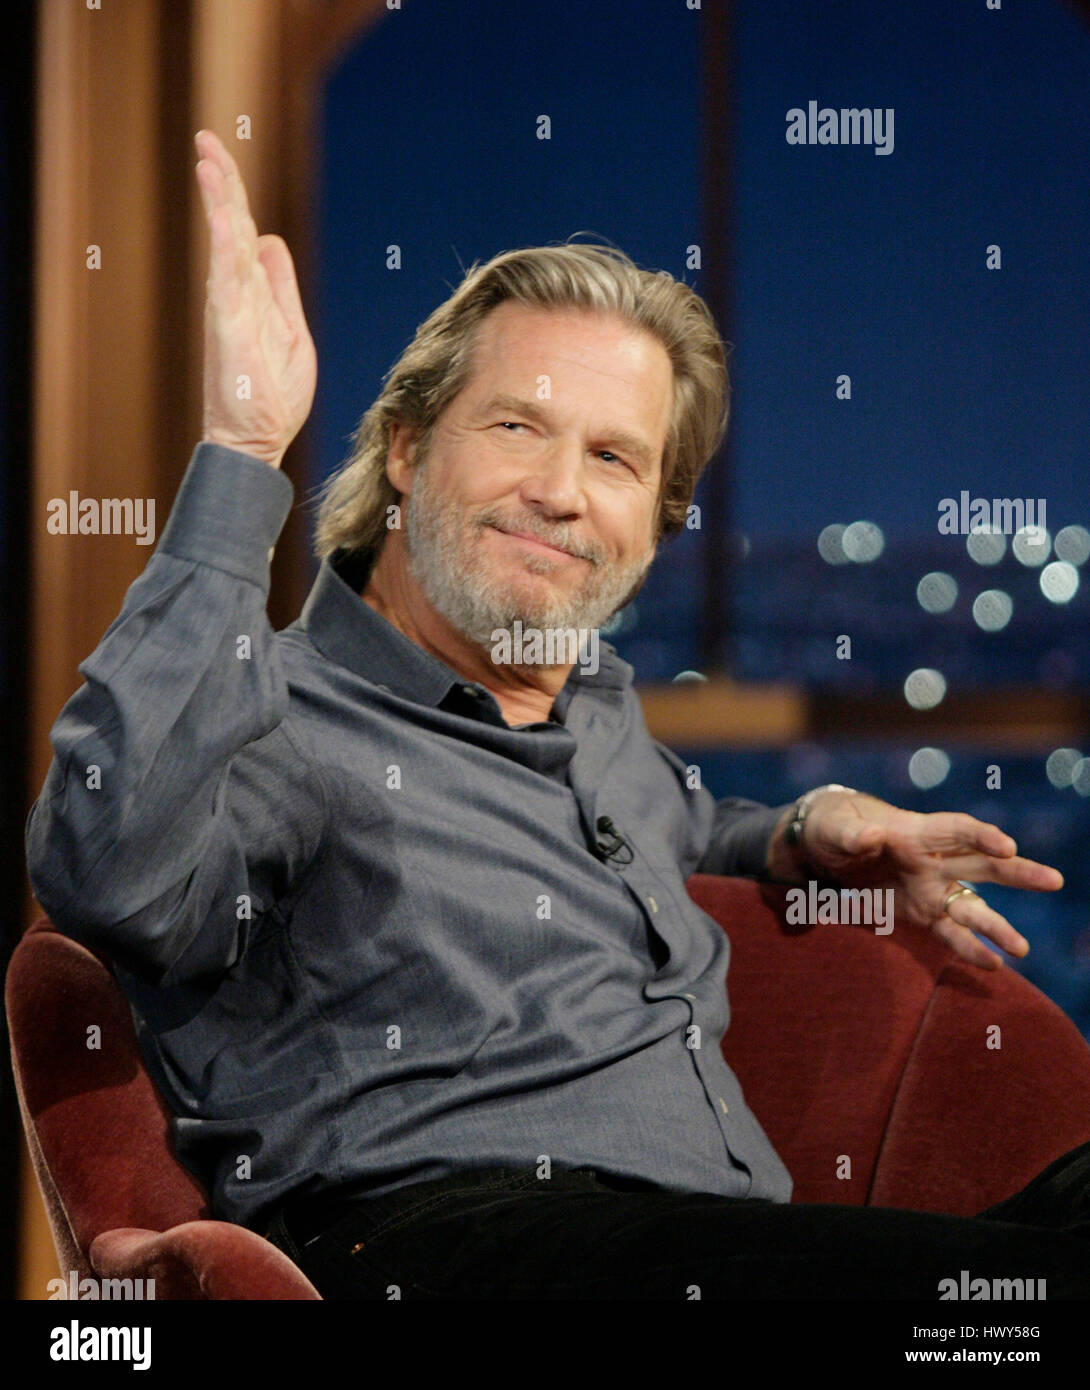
[{"xmin": 688, "ymin": 874, "xmax": 1090, "ymax": 1216}]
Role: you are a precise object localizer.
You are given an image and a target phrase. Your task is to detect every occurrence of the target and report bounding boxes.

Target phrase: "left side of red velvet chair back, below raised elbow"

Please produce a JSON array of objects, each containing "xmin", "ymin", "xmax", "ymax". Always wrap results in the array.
[{"xmin": 4, "ymin": 917, "xmax": 211, "ymax": 1276}]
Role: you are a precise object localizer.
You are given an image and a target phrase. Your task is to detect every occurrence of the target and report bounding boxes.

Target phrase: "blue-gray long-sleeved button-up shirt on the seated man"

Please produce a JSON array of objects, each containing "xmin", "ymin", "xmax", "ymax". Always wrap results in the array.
[{"xmin": 26, "ymin": 443, "xmax": 791, "ymax": 1229}]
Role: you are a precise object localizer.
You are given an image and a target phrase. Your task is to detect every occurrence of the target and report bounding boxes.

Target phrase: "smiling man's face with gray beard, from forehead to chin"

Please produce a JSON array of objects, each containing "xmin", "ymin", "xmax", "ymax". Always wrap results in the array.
[{"xmin": 388, "ymin": 302, "xmax": 673, "ymax": 646}]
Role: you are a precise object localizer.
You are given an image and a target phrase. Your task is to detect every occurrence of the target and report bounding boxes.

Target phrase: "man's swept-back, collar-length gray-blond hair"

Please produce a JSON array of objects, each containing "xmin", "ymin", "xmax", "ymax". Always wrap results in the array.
[{"xmin": 316, "ymin": 242, "xmax": 730, "ymax": 559}]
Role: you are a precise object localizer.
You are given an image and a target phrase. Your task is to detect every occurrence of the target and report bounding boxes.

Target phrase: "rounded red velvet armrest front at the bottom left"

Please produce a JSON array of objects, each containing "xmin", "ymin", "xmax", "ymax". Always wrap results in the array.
[{"xmin": 89, "ymin": 1220, "xmax": 321, "ymax": 1300}]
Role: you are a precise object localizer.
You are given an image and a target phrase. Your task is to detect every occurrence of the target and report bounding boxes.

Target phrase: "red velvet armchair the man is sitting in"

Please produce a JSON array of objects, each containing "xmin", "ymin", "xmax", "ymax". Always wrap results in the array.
[{"xmin": 6, "ymin": 874, "xmax": 1090, "ymax": 1298}]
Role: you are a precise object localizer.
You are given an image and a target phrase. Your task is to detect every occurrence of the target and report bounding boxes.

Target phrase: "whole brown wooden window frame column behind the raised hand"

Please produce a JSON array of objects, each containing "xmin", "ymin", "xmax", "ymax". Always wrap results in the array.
[{"xmin": 19, "ymin": 0, "xmax": 387, "ymax": 1300}]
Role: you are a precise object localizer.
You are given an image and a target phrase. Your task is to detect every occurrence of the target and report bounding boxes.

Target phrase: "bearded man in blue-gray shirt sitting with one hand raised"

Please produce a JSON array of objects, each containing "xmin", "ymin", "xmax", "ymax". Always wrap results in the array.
[{"xmin": 28, "ymin": 132, "xmax": 1090, "ymax": 1298}]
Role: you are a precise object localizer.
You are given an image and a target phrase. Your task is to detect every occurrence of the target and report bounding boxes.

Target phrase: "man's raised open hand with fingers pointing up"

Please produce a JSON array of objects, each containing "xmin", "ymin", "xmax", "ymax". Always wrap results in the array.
[{"xmin": 195, "ymin": 131, "xmax": 317, "ymax": 468}]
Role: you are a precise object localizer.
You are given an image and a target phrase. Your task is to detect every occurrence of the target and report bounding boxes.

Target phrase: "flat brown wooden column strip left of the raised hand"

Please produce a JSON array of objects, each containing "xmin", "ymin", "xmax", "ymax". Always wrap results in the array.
[{"xmin": 19, "ymin": 0, "xmax": 168, "ymax": 1298}]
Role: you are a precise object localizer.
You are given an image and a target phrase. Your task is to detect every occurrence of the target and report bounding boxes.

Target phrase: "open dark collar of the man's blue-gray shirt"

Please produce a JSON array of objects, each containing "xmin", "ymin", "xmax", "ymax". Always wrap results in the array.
[{"xmin": 292, "ymin": 550, "xmax": 633, "ymax": 717}]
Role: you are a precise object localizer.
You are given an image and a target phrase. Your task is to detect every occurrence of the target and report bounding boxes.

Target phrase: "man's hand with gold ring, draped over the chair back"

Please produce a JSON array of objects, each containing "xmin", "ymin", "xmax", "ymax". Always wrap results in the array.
[{"xmin": 769, "ymin": 791, "xmax": 1064, "ymax": 970}]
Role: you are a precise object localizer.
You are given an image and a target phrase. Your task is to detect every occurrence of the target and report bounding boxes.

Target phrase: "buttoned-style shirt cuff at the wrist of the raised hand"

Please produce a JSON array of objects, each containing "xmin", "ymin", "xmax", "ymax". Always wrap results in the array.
[{"xmin": 156, "ymin": 442, "xmax": 295, "ymax": 592}]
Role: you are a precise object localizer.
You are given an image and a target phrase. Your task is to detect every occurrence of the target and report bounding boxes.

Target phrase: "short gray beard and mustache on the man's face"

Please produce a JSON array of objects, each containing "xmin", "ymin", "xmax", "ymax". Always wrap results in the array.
[{"xmin": 405, "ymin": 459, "xmax": 653, "ymax": 649}]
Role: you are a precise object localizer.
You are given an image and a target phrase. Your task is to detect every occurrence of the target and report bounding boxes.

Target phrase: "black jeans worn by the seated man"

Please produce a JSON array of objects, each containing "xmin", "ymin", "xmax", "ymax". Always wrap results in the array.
[{"xmin": 267, "ymin": 1143, "xmax": 1090, "ymax": 1307}]
